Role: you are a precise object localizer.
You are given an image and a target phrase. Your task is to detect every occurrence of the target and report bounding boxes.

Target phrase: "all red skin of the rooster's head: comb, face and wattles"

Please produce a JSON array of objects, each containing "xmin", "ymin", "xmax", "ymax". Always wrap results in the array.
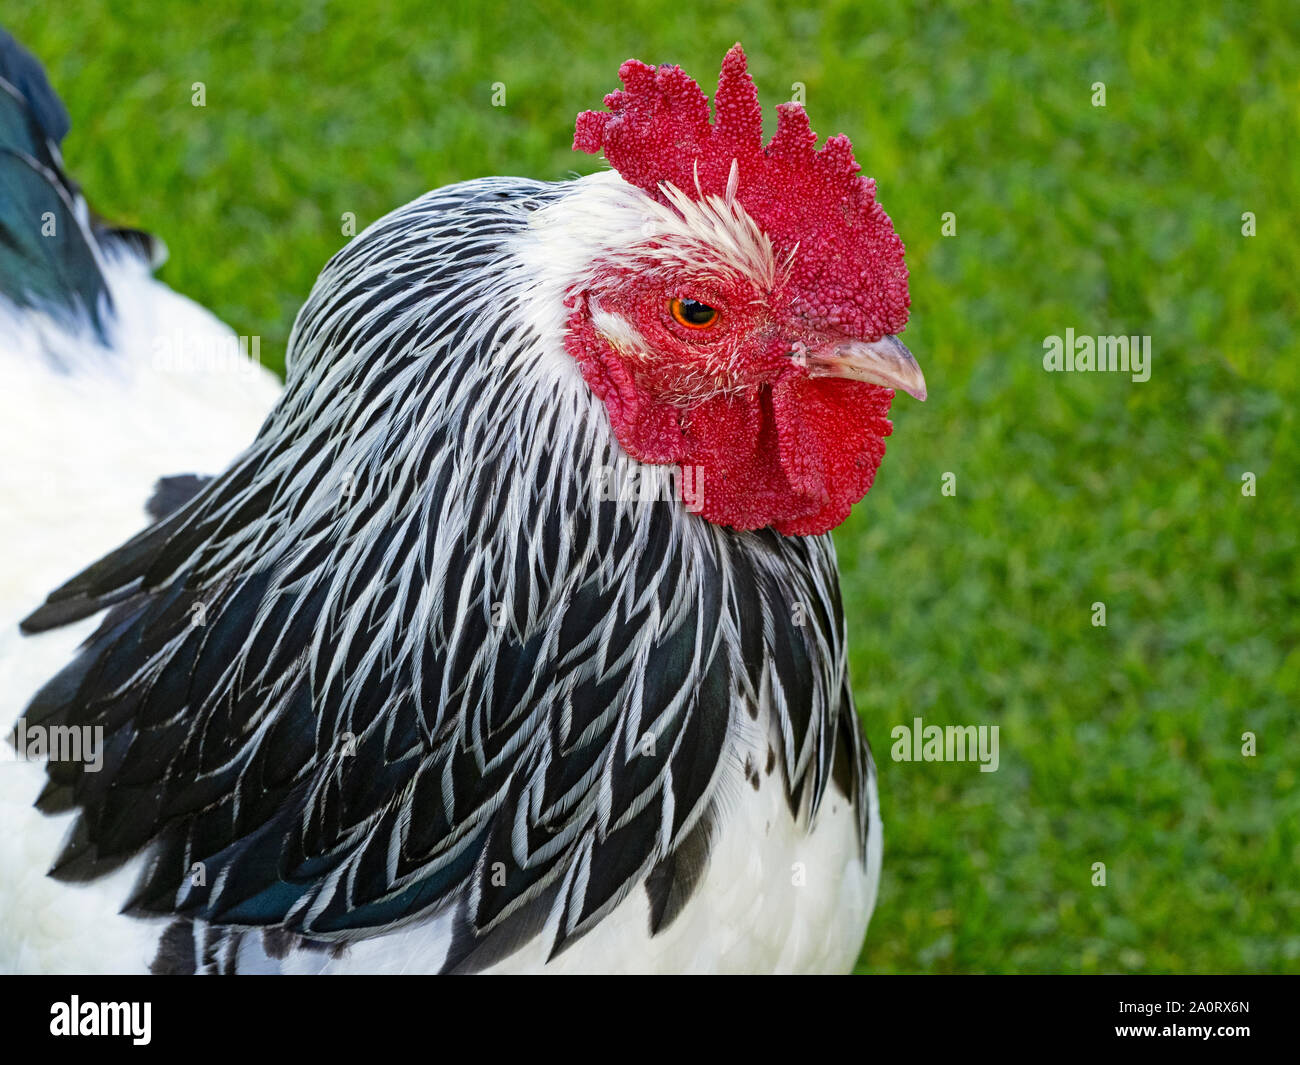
[{"xmin": 566, "ymin": 46, "xmax": 909, "ymax": 536}]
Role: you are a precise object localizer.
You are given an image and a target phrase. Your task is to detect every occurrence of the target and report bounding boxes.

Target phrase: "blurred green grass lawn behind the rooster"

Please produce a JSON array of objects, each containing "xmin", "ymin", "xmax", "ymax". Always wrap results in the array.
[{"xmin": 0, "ymin": 0, "xmax": 1300, "ymax": 973}]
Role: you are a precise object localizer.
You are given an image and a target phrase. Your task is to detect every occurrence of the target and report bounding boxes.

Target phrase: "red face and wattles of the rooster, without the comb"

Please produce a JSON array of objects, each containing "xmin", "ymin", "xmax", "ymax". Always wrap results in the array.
[{"xmin": 567, "ymin": 272, "xmax": 893, "ymax": 536}]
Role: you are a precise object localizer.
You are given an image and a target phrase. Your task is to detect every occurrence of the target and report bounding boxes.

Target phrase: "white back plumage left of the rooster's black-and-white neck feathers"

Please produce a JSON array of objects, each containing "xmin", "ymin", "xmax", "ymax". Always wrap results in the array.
[{"xmin": 0, "ymin": 259, "xmax": 281, "ymax": 973}]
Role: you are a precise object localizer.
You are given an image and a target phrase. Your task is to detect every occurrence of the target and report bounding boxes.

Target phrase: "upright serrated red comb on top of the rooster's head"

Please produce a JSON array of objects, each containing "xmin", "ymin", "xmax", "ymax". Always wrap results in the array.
[{"xmin": 573, "ymin": 44, "xmax": 910, "ymax": 338}]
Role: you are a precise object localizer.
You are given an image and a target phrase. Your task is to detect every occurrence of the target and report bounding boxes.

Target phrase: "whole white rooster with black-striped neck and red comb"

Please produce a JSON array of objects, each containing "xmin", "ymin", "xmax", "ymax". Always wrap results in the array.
[{"xmin": 0, "ymin": 39, "xmax": 926, "ymax": 973}]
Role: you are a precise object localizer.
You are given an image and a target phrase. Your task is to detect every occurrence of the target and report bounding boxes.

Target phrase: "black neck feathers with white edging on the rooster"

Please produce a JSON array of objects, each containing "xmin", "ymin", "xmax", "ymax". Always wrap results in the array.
[{"xmin": 17, "ymin": 174, "xmax": 874, "ymax": 970}]
